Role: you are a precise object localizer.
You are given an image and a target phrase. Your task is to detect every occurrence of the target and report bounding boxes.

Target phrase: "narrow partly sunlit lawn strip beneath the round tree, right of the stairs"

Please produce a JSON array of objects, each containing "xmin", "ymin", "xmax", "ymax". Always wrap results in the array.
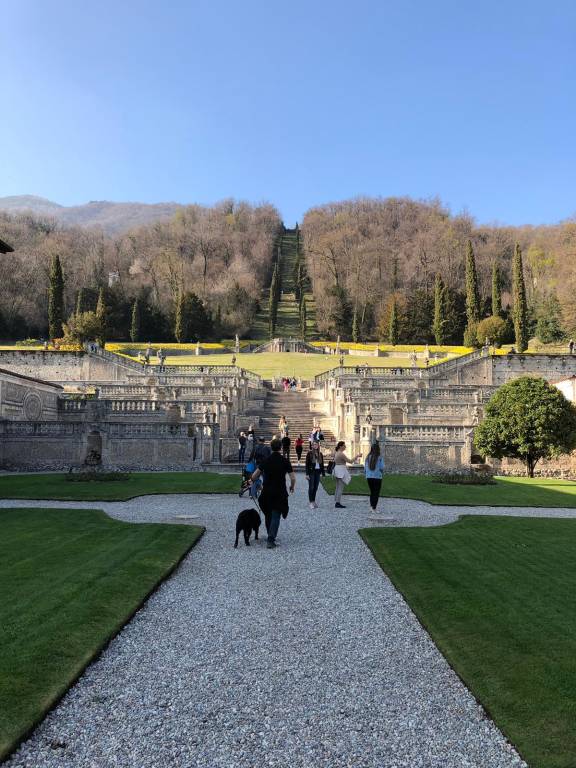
[{"xmin": 322, "ymin": 475, "xmax": 576, "ymax": 510}]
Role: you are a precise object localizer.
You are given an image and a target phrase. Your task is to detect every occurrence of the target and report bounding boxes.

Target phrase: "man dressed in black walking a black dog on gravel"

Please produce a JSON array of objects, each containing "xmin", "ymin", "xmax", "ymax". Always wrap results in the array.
[{"xmin": 252, "ymin": 438, "xmax": 296, "ymax": 549}]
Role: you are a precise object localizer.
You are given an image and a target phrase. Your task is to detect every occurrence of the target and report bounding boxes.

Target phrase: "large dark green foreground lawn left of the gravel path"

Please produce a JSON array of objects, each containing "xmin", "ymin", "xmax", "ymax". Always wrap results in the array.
[{"xmin": 0, "ymin": 509, "xmax": 202, "ymax": 759}]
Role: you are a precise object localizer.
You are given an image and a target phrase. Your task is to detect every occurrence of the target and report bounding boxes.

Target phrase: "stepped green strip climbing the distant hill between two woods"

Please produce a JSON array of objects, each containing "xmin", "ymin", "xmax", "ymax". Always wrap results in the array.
[{"xmin": 251, "ymin": 229, "xmax": 318, "ymax": 341}]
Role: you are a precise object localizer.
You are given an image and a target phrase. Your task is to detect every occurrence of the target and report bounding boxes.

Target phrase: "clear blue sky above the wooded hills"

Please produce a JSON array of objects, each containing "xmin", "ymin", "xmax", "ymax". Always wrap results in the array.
[{"xmin": 0, "ymin": 0, "xmax": 576, "ymax": 225}]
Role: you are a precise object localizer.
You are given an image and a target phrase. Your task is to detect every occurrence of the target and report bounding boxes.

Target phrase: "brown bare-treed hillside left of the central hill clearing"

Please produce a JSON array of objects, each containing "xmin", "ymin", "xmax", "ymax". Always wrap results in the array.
[{"xmin": 0, "ymin": 200, "xmax": 281, "ymax": 339}]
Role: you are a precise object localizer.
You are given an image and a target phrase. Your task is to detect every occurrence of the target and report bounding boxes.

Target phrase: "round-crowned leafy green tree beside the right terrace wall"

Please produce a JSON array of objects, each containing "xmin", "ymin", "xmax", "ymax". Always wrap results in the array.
[{"xmin": 474, "ymin": 376, "xmax": 576, "ymax": 477}]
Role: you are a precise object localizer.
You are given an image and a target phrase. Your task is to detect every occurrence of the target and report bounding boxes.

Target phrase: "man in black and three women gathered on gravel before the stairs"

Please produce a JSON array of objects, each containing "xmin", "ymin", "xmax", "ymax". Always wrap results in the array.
[{"xmin": 250, "ymin": 437, "xmax": 384, "ymax": 549}]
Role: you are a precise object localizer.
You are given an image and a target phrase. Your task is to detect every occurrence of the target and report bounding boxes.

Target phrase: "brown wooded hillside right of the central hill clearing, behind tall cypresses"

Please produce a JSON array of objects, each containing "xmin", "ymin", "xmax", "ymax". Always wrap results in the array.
[{"xmin": 302, "ymin": 198, "xmax": 576, "ymax": 343}]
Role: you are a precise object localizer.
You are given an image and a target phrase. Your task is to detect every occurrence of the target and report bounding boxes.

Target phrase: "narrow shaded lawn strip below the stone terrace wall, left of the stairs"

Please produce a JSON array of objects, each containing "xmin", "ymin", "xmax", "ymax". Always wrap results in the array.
[{"xmin": 0, "ymin": 472, "xmax": 240, "ymax": 501}]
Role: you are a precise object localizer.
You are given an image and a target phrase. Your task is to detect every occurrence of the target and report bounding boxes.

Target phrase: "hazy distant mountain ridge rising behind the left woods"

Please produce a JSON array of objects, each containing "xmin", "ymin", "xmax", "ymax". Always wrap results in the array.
[{"xmin": 0, "ymin": 195, "xmax": 183, "ymax": 235}]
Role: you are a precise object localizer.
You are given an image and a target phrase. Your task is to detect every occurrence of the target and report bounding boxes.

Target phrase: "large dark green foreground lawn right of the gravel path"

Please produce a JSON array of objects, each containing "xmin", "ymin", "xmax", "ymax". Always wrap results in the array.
[{"xmin": 360, "ymin": 516, "xmax": 576, "ymax": 768}]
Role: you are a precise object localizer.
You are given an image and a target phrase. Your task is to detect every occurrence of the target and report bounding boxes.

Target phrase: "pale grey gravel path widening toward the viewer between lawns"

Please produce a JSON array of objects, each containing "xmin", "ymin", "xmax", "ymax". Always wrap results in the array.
[{"xmin": 0, "ymin": 484, "xmax": 576, "ymax": 768}]
